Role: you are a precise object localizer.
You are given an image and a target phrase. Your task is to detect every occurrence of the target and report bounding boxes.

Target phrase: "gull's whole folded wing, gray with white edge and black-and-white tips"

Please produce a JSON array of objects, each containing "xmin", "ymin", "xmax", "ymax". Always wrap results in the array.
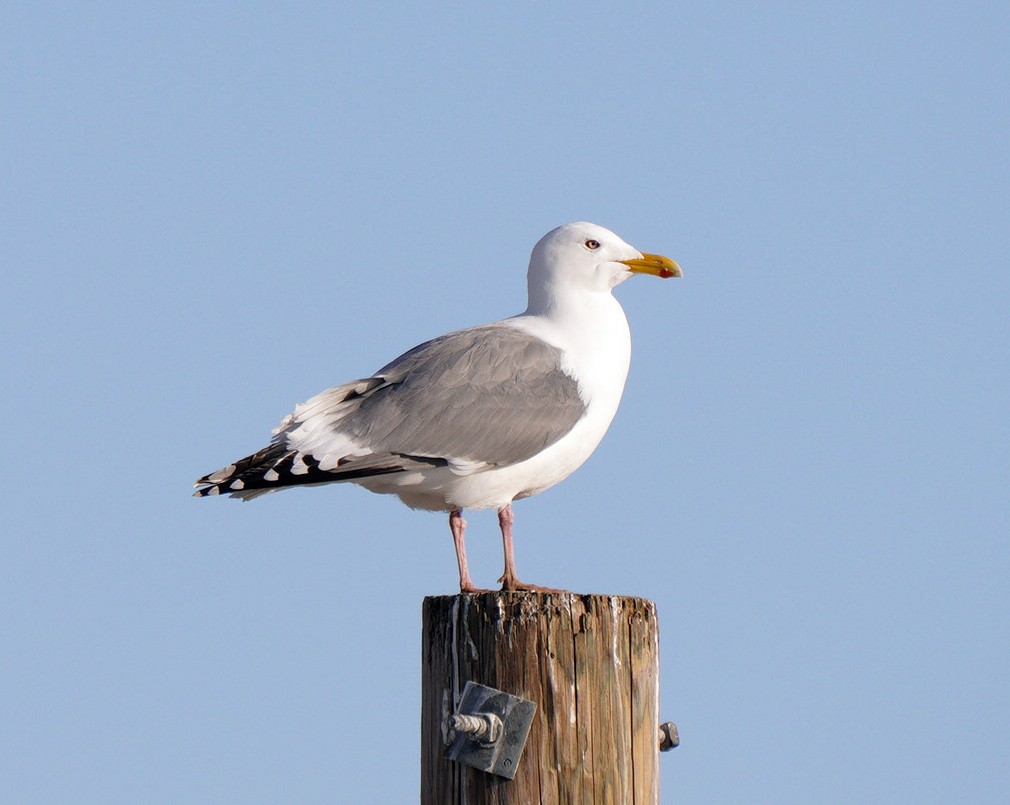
[{"xmin": 194, "ymin": 324, "xmax": 586, "ymax": 498}]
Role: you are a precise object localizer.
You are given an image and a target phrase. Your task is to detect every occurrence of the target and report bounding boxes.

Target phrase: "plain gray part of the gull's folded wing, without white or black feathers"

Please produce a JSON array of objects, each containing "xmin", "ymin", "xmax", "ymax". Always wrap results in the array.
[{"xmin": 334, "ymin": 324, "xmax": 586, "ymax": 467}]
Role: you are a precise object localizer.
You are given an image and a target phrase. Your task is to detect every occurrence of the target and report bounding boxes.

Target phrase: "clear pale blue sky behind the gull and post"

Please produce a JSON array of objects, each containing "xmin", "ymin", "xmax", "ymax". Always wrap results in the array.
[{"xmin": 0, "ymin": 2, "xmax": 1010, "ymax": 803}]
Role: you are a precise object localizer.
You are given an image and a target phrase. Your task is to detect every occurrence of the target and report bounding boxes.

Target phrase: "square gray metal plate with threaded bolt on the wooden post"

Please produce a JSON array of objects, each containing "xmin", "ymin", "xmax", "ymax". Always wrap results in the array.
[{"xmin": 442, "ymin": 682, "xmax": 536, "ymax": 780}]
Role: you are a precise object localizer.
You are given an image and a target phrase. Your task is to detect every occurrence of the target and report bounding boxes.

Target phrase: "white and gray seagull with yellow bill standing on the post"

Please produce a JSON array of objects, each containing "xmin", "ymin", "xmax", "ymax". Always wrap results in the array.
[{"xmin": 194, "ymin": 222, "xmax": 683, "ymax": 593}]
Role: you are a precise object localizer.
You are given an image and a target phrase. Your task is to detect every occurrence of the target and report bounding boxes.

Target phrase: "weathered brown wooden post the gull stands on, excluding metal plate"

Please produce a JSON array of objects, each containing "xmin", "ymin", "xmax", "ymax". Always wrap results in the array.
[{"xmin": 421, "ymin": 592, "xmax": 660, "ymax": 805}]
